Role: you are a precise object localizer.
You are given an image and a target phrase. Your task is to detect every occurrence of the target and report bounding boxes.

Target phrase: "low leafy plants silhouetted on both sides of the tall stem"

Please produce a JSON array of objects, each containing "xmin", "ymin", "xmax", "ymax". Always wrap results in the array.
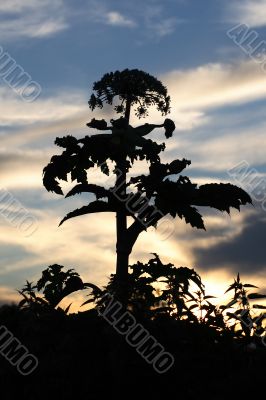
[{"xmin": 19, "ymin": 253, "xmax": 266, "ymax": 343}]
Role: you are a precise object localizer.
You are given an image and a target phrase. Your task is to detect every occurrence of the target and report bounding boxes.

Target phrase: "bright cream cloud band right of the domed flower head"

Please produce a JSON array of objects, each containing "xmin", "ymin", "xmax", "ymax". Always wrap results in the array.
[{"xmin": 161, "ymin": 60, "xmax": 266, "ymax": 110}]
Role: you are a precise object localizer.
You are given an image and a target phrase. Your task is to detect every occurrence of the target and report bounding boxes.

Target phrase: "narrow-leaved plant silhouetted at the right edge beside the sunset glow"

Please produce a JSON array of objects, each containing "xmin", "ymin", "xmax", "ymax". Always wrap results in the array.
[{"xmin": 220, "ymin": 273, "xmax": 266, "ymax": 339}]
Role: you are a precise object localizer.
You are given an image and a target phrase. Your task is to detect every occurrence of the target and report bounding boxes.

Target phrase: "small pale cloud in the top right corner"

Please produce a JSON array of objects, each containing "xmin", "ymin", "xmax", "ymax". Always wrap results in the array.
[{"xmin": 228, "ymin": 0, "xmax": 266, "ymax": 27}]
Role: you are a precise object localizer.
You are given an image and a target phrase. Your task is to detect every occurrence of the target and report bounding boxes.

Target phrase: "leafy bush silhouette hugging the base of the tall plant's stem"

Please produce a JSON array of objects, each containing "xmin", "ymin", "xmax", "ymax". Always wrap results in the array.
[{"xmin": 82, "ymin": 253, "xmax": 204, "ymax": 319}]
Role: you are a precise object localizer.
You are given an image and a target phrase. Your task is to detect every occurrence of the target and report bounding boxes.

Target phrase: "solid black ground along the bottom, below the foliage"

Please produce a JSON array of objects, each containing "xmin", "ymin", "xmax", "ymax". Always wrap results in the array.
[{"xmin": 0, "ymin": 306, "xmax": 266, "ymax": 400}]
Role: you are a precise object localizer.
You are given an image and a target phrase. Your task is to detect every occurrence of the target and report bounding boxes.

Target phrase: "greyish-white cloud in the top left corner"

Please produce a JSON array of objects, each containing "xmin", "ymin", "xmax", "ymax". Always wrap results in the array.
[{"xmin": 0, "ymin": 0, "xmax": 68, "ymax": 40}]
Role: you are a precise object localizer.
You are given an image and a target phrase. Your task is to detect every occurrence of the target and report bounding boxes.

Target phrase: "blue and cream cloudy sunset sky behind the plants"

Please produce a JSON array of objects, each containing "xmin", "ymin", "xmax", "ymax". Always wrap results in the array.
[{"xmin": 0, "ymin": 0, "xmax": 266, "ymax": 310}]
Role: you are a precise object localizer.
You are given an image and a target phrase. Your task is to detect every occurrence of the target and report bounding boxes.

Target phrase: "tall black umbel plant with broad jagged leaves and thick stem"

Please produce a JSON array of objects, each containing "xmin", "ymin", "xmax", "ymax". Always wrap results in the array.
[{"xmin": 43, "ymin": 69, "xmax": 251, "ymax": 305}]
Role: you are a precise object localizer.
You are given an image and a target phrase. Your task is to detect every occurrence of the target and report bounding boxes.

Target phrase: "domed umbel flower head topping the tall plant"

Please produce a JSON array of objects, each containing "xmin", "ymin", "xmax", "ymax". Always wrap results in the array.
[{"xmin": 88, "ymin": 69, "xmax": 170, "ymax": 118}]
